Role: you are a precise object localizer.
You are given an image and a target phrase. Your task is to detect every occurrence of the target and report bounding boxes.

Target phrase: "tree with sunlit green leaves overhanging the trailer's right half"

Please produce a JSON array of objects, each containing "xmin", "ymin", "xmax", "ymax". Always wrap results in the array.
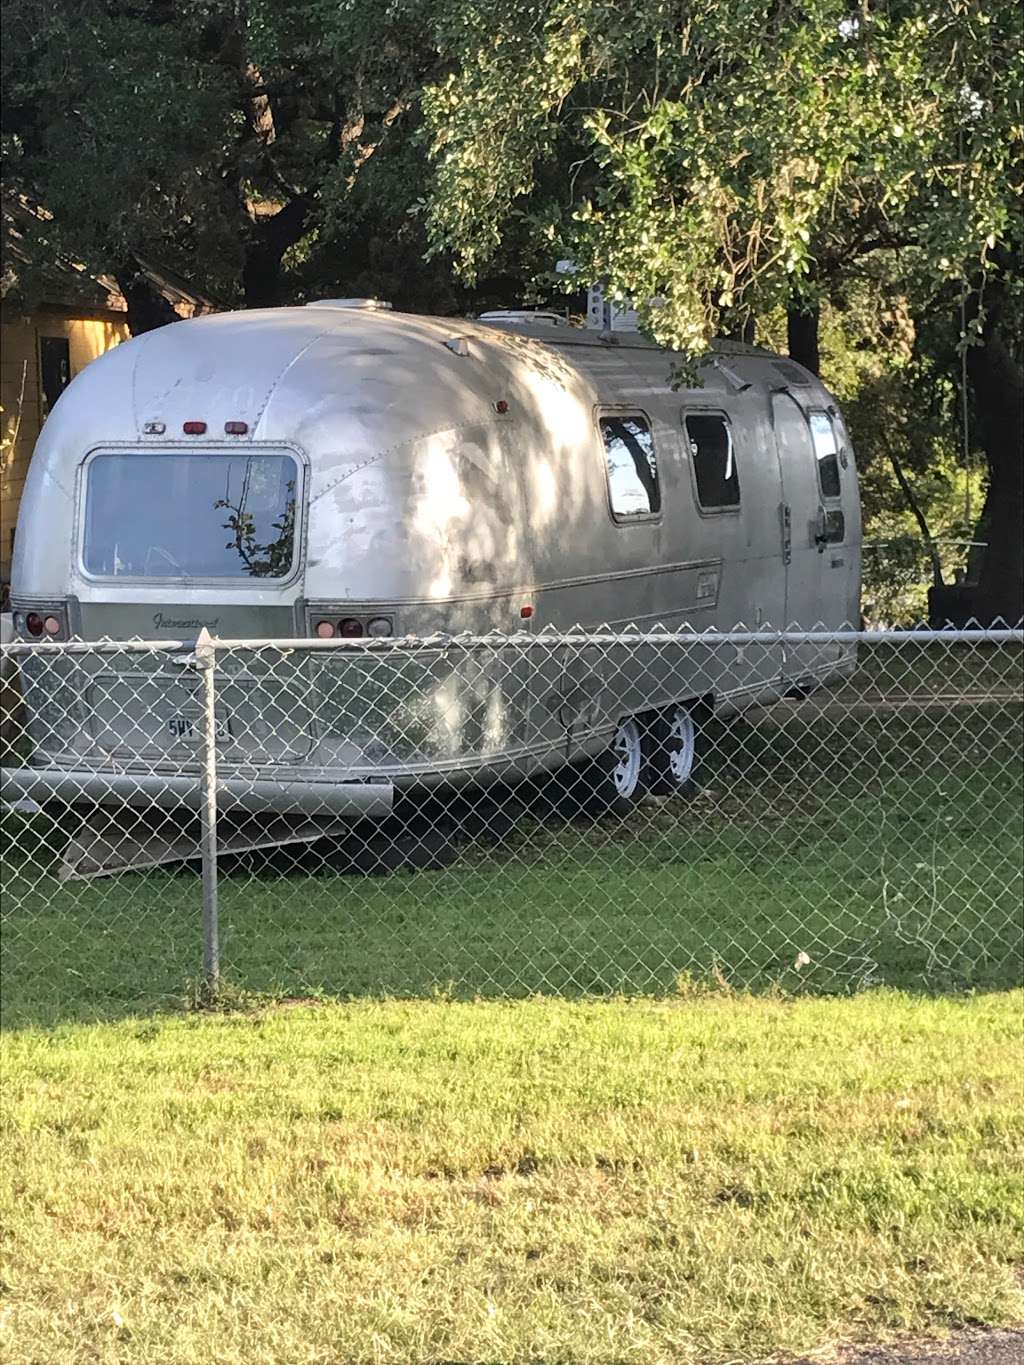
[{"xmin": 425, "ymin": 0, "xmax": 1024, "ymax": 620}]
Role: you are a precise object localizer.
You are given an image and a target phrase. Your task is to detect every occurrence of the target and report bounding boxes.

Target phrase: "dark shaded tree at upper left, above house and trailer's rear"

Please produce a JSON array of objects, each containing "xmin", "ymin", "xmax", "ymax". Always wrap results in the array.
[{"xmin": 3, "ymin": 0, "xmax": 445, "ymax": 316}]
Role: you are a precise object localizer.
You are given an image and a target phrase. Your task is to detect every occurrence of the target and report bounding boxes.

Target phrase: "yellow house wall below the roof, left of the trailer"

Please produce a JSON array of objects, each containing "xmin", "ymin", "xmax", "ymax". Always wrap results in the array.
[{"xmin": 0, "ymin": 308, "xmax": 128, "ymax": 583}]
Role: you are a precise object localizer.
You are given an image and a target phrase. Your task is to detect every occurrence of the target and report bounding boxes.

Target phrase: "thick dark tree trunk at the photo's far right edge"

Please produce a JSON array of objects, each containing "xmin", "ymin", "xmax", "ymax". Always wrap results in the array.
[{"xmin": 967, "ymin": 315, "xmax": 1024, "ymax": 625}]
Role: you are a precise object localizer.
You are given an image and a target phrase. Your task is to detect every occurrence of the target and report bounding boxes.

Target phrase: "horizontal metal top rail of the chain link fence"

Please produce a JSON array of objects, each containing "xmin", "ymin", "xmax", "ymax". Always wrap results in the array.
[{"xmin": 0, "ymin": 628, "xmax": 1024, "ymax": 663}]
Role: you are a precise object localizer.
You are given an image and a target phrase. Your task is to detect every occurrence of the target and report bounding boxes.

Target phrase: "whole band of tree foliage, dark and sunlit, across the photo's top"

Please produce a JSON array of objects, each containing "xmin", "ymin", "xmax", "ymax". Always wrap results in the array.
[{"xmin": 3, "ymin": 0, "xmax": 1024, "ymax": 347}]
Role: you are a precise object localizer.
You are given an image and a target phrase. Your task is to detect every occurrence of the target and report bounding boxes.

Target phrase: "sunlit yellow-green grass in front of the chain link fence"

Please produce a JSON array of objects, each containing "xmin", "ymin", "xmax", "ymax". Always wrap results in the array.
[{"xmin": 0, "ymin": 991, "xmax": 1024, "ymax": 1365}]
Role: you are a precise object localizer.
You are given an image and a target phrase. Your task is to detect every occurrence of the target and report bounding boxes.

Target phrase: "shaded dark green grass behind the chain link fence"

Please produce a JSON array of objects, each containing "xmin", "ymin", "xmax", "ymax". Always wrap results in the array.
[{"xmin": 3, "ymin": 711, "xmax": 1021, "ymax": 1028}]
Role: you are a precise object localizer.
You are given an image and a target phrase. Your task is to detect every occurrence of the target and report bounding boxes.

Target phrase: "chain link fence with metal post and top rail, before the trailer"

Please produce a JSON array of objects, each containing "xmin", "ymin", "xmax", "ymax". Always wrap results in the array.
[{"xmin": 1, "ymin": 631, "xmax": 1024, "ymax": 1024}]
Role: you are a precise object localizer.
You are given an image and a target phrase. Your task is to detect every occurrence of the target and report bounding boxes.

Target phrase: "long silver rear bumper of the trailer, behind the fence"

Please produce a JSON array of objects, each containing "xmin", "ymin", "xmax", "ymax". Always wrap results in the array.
[{"xmin": 0, "ymin": 767, "xmax": 395, "ymax": 820}]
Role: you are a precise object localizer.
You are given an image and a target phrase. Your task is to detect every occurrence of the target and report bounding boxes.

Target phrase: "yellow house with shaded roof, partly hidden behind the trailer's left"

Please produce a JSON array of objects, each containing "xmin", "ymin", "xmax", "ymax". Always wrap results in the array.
[{"xmin": 0, "ymin": 198, "xmax": 214, "ymax": 584}]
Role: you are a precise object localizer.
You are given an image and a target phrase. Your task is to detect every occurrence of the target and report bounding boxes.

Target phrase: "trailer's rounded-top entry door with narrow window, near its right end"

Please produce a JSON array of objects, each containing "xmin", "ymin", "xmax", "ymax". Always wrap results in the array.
[{"xmin": 771, "ymin": 392, "xmax": 856, "ymax": 683}]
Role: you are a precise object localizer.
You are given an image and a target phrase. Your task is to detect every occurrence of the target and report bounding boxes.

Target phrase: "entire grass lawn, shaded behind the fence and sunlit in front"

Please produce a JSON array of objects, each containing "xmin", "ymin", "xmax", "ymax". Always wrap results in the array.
[{"xmin": 0, "ymin": 661, "xmax": 1024, "ymax": 1365}]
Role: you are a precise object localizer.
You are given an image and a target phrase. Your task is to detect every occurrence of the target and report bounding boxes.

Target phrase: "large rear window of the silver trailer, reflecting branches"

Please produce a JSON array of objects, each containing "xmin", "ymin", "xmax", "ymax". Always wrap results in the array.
[{"xmin": 82, "ymin": 450, "xmax": 299, "ymax": 579}]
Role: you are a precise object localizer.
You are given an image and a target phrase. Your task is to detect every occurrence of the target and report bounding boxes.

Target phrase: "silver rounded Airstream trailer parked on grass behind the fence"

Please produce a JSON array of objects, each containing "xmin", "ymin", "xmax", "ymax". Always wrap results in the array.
[{"xmin": 4, "ymin": 299, "xmax": 860, "ymax": 873}]
